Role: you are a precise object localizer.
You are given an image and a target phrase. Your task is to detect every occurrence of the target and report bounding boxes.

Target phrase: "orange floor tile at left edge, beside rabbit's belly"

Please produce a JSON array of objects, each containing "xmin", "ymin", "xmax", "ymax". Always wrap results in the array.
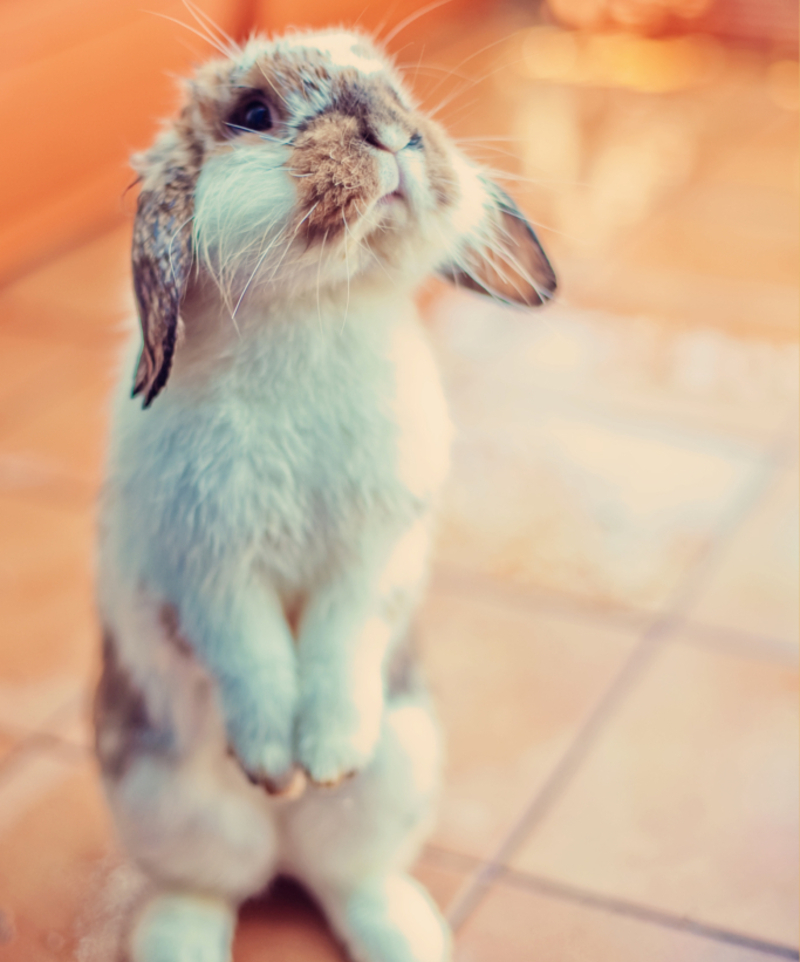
[{"xmin": 0, "ymin": 496, "xmax": 99, "ymax": 684}]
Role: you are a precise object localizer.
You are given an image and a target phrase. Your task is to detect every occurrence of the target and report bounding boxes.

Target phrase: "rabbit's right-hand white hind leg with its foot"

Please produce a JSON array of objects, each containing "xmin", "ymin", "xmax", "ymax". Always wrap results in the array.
[{"xmin": 281, "ymin": 697, "xmax": 451, "ymax": 962}]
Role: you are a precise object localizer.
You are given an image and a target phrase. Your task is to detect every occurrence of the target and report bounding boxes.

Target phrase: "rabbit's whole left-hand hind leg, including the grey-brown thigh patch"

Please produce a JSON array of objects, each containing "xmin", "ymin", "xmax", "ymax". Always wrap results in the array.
[{"xmin": 95, "ymin": 632, "xmax": 276, "ymax": 962}]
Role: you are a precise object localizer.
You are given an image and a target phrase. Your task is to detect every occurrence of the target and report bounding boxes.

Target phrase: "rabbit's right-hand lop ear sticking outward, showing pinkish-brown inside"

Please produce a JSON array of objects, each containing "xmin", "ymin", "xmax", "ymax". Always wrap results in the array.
[{"xmin": 439, "ymin": 176, "xmax": 557, "ymax": 307}]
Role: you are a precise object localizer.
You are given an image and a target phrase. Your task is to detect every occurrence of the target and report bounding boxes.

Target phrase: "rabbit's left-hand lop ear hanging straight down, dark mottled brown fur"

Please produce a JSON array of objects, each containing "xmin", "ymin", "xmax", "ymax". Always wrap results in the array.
[{"xmin": 131, "ymin": 158, "xmax": 197, "ymax": 407}]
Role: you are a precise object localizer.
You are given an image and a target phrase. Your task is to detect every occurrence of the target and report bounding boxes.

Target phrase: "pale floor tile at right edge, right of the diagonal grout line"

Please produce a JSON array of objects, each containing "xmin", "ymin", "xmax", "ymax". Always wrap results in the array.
[{"xmin": 689, "ymin": 465, "xmax": 800, "ymax": 649}]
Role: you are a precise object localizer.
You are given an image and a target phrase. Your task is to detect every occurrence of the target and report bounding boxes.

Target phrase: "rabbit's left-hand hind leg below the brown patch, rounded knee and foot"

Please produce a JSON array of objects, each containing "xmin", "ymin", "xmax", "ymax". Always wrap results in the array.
[{"xmin": 107, "ymin": 732, "xmax": 276, "ymax": 962}]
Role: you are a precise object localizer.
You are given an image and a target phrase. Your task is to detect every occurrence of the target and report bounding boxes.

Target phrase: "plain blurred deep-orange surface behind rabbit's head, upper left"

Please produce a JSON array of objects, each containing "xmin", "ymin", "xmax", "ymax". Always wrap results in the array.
[{"xmin": 0, "ymin": 0, "xmax": 480, "ymax": 282}]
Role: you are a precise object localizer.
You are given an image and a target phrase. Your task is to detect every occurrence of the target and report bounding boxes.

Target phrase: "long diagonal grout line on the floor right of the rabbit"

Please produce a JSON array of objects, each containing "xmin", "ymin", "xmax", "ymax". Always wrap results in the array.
[{"xmin": 447, "ymin": 440, "xmax": 787, "ymax": 930}]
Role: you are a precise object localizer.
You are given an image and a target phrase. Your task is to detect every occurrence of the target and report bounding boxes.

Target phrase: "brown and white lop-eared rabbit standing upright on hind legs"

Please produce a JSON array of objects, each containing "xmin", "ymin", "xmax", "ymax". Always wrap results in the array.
[{"xmin": 95, "ymin": 30, "xmax": 556, "ymax": 962}]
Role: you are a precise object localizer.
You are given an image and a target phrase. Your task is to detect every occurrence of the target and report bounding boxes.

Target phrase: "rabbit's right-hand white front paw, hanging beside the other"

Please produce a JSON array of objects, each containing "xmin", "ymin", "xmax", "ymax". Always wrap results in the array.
[{"xmin": 297, "ymin": 695, "xmax": 383, "ymax": 787}]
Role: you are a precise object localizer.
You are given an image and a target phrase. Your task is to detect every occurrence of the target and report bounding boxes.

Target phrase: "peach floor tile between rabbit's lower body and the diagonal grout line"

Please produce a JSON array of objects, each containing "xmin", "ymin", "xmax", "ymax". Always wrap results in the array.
[{"xmin": 420, "ymin": 591, "xmax": 636, "ymax": 856}]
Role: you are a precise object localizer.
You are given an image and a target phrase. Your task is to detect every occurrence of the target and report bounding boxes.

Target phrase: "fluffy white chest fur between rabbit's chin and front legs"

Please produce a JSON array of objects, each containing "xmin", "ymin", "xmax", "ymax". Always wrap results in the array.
[{"xmin": 101, "ymin": 294, "xmax": 450, "ymax": 587}]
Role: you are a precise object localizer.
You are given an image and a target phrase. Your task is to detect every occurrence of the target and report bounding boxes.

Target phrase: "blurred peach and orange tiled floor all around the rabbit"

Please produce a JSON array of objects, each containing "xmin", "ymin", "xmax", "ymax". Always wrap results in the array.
[{"xmin": 0, "ymin": 9, "xmax": 798, "ymax": 962}]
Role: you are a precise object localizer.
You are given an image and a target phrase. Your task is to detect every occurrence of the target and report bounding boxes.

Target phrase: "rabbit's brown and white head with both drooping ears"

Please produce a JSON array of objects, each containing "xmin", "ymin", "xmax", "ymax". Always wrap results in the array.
[{"xmin": 133, "ymin": 31, "xmax": 556, "ymax": 406}]
